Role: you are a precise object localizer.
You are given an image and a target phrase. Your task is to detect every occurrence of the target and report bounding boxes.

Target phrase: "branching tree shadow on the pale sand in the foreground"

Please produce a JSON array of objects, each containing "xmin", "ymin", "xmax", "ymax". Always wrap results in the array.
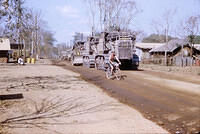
[{"xmin": 0, "ymin": 96, "xmax": 118, "ymax": 134}]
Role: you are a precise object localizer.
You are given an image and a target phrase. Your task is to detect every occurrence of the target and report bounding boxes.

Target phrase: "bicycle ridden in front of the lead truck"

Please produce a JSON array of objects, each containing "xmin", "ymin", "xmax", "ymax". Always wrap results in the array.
[{"xmin": 106, "ymin": 63, "xmax": 121, "ymax": 80}]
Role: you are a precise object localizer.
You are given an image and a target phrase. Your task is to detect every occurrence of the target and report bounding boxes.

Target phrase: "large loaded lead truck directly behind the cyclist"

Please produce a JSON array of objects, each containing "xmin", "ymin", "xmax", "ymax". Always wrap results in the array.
[{"xmin": 94, "ymin": 31, "xmax": 139, "ymax": 69}]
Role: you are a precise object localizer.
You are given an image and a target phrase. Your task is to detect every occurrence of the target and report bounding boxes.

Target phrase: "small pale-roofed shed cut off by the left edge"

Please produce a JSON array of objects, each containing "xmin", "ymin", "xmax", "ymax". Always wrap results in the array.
[{"xmin": 0, "ymin": 37, "xmax": 10, "ymax": 63}]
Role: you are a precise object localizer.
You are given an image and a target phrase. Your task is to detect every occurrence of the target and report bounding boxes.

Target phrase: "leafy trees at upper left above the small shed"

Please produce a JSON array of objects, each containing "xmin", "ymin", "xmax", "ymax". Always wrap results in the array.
[{"xmin": 0, "ymin": 0, "xmax": 58, "ymax": 58}]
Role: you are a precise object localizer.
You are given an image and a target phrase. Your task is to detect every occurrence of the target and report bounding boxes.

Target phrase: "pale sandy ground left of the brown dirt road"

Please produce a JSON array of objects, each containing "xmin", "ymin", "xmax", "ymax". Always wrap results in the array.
[{"xmin": 0, "ymin": 64, "xmax": 168, "ymax": 134}]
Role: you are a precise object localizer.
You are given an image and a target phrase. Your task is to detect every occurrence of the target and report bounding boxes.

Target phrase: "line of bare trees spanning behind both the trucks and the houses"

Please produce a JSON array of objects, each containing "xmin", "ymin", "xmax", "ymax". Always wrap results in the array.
[{"xmin": 84, "ymin": 0, "xmax": 200, "ymax": 44}]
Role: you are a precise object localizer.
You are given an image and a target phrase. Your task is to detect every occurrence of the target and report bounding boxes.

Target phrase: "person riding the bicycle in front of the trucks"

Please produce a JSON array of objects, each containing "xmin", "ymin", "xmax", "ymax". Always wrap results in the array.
[{"xmin": 109, "ymin": 51, "xmax": 121, "ymax": 74}]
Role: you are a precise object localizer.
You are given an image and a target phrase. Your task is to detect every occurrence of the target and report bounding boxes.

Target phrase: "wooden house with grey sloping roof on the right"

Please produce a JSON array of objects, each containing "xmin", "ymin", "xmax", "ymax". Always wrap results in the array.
[{"xmin": 150, "ymin": 39, "xmax": 200, "ymax": 66}]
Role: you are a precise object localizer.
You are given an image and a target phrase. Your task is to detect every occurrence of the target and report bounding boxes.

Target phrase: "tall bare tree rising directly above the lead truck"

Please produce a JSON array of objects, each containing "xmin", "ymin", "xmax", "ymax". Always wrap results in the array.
[{"xmin": 86, "ymin": 0, "xmax": 138, "ymax": 30}]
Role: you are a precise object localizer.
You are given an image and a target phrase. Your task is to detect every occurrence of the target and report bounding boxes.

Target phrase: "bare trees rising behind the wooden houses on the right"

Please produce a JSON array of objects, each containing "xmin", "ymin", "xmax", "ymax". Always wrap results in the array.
[{"xmin": 145, "ymin": 9, "xmax": 200, "ymax": 44}]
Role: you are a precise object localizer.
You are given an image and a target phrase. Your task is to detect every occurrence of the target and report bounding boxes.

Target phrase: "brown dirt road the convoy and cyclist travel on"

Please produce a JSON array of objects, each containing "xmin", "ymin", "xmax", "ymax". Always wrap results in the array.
[{"xmin": 56, "ymin": 63, "xmax": 200, "ymax": 133}]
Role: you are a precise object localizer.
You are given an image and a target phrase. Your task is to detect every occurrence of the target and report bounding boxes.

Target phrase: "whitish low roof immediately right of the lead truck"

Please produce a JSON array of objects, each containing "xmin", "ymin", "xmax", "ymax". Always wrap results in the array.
[{"xmin": 135, "ymin": 42, "xmax": 165, "ymax": 49}]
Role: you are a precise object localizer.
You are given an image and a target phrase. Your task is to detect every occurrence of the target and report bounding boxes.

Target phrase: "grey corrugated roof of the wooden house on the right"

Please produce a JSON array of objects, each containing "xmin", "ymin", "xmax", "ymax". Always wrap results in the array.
[{"xmin": 150, "ymin": 39, "xmax": 188, "ymax": 53}]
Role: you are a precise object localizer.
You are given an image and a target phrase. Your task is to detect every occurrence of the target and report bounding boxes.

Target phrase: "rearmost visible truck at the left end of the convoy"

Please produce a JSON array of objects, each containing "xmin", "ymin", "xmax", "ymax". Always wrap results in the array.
[{"xmin": 71, "ymin": 41, "xmax": 85, "ymax": 66}]
